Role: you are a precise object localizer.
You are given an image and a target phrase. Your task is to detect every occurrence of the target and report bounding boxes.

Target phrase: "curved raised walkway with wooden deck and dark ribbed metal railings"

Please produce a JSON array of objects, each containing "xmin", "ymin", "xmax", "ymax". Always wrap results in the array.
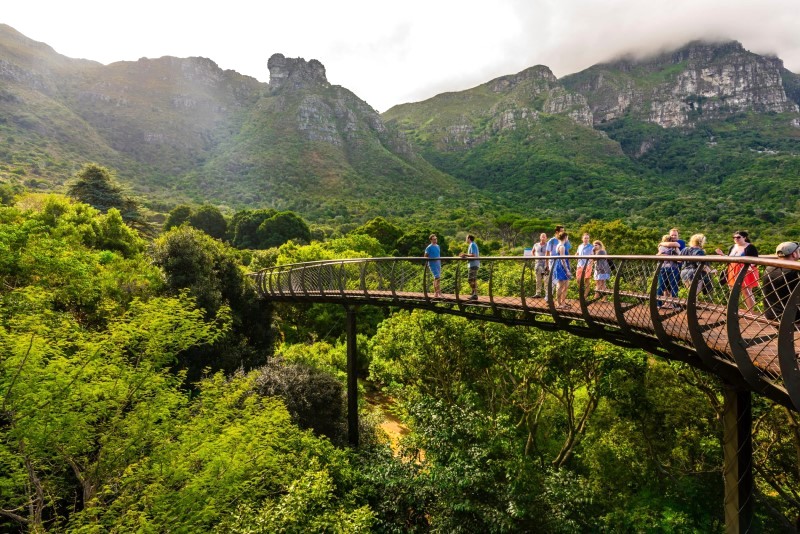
[{"xmin": 254, "ymin": 256, "xmax": 800, "ymax": 410}]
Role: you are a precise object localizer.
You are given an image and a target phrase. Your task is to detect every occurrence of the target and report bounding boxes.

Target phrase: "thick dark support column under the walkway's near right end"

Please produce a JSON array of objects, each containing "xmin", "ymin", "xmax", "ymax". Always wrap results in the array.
[{"xmin": 722, "ymin": 387, "xmax": 754, "ymax": 534}]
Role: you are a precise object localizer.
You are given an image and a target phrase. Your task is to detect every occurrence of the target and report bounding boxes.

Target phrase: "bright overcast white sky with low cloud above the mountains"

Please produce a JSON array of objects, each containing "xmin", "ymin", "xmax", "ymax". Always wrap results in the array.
[{"xmin": 0, "ymin": 0, "xmax": 800, "ymax": 112}]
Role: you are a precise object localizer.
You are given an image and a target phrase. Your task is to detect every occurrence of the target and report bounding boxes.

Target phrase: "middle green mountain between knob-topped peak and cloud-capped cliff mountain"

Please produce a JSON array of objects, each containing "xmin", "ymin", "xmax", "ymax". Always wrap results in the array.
[{"xmin": 383, "ymin": 66, "xmax": 652, "ymax": 221}]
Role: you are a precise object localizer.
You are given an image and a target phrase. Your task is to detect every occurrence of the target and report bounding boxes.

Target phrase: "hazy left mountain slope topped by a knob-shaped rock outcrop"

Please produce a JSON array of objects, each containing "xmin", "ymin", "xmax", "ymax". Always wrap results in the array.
[{"xmin": 0, "ymin": 26, "xmax": 480, "ymax": 224}]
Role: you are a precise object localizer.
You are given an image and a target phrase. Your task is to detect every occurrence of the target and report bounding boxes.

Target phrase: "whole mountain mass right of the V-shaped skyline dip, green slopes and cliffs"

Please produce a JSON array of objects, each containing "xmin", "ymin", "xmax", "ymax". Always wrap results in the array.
[{"xmin": 383, "ymin": 42, "xmax": 800, "ymax": 231}]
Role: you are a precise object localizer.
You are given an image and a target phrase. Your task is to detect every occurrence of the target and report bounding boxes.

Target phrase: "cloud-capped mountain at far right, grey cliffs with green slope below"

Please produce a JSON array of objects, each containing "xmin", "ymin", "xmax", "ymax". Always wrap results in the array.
[{"xmin": 561, "ymin": 42, "xmax": 800, "ymax": 231}]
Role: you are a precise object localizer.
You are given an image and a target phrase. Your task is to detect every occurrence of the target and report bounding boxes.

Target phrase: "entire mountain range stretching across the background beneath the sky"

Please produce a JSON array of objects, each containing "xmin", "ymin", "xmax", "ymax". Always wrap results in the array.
[{"xmin": 0, "ymin": 25, "xmax": 800, "ymax": 232}]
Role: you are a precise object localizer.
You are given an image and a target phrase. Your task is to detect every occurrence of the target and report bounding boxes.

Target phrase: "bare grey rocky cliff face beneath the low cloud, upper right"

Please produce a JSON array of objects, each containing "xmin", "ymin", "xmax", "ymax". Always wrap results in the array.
[{"xmin": 561, "ymin": 42, "xmax": 798, "ymax": 127}]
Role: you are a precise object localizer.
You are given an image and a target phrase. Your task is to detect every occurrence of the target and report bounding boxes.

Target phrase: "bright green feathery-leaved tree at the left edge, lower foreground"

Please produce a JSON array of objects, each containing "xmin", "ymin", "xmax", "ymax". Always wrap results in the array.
[{"xmin": 0, "ymin": 288, "xmax": 226, "ymax": 532}]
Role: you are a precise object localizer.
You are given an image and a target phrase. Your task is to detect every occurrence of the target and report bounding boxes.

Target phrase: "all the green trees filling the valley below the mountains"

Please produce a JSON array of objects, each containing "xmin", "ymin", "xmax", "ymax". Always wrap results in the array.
[{"xmin": 0, "ymin": 164, "xmax": 800, "ymax": 533}]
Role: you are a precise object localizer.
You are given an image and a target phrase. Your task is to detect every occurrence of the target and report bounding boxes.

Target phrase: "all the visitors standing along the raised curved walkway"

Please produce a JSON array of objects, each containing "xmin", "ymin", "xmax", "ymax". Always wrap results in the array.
[{"xmin": 425, "ymin": 225, "xmax": 800, "ymax": 320}]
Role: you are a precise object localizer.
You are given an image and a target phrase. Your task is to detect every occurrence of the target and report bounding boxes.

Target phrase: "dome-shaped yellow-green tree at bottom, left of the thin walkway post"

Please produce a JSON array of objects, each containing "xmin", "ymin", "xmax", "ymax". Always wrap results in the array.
[{"xmin": 68, "ymin": 373, "xmax": 373, "ymax": 534}]
